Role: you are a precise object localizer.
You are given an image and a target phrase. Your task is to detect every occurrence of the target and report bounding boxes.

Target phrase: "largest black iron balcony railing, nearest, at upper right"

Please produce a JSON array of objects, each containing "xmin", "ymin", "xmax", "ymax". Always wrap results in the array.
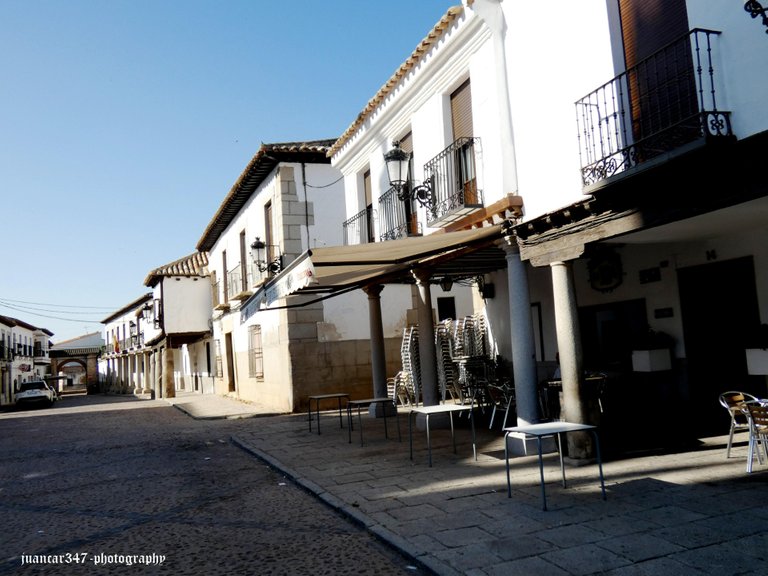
[{"xmin": 576, "ymin": 28, "xmax": 733, "ymax": 188}]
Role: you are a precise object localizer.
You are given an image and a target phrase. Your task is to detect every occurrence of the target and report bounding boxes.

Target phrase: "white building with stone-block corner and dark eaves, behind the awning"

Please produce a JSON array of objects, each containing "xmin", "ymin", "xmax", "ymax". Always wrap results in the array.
[{"xmin": 197, "ymin": 140, "xmax": 397, "ymax": 412}]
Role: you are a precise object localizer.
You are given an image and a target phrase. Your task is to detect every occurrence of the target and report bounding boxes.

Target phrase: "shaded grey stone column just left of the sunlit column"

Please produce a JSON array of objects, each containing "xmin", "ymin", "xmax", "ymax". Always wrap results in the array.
[{"xmin": 503, "ymin": 239, "xmax": 539, "ymax": 426}]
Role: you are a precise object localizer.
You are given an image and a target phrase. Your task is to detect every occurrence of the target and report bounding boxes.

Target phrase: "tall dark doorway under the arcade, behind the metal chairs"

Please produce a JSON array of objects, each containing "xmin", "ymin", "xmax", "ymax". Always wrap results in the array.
[{"xmin": 677, "ymin": 256, "xmax": 766, "ymax": 436}]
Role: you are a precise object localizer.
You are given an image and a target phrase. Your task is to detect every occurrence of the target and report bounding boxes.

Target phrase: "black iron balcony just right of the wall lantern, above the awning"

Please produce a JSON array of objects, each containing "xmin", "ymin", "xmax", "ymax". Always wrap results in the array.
[{"xmin": 424, "ymin": 138, "xmax": 483, "ymax": 227}]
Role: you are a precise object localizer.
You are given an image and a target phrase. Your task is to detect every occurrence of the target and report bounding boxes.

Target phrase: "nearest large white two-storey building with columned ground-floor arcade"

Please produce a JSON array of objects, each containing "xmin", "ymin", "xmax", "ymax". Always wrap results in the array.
[{"xmin": 282, "ymin": 0, "xmax": 768, "ymax": 457}]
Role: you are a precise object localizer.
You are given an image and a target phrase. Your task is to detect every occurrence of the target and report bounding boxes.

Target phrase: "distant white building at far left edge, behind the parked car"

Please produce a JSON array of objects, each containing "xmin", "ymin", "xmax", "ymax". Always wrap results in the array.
[{"xmin": 0, "ymin": 316, "xmax": 53, "ymax": 406}]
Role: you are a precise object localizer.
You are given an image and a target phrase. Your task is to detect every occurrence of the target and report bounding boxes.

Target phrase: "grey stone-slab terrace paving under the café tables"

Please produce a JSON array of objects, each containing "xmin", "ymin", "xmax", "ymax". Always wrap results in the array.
[{"xmin": 168, "ymin": 400, "xmax": 768, "ymax": 576}]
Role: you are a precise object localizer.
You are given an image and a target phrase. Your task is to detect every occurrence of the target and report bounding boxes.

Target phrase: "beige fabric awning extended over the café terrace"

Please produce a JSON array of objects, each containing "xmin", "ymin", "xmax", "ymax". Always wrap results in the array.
[{"xmin": 241, "ymin": 224, "xmax": 506, "ymax": 321}]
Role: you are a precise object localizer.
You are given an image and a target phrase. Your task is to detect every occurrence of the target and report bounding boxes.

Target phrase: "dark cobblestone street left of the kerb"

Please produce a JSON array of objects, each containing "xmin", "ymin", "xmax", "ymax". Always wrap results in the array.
[{"xmin": 0, "ymin": 396, "xmax": 425, "ymax": 576}]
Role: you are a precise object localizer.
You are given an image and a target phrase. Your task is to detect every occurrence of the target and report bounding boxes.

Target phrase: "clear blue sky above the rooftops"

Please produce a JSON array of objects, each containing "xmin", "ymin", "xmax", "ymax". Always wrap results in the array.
[{"xmin": 0, "ymin": 0, "xmax": 452, "ymax": 342}]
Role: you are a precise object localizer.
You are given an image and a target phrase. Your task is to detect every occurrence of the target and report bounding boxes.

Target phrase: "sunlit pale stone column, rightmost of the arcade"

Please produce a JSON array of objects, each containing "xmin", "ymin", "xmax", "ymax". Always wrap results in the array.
[{"xmin": 550, "ymin": 262, "xmax": 593, "ymax": 458}]
